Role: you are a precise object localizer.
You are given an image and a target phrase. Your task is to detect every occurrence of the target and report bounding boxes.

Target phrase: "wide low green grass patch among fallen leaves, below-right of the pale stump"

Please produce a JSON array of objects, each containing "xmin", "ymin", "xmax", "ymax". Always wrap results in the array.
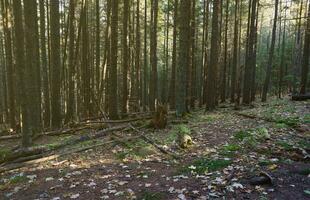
[{"xmin": 179, "ymin": 158, "xmax": 232, "ymax": 175}]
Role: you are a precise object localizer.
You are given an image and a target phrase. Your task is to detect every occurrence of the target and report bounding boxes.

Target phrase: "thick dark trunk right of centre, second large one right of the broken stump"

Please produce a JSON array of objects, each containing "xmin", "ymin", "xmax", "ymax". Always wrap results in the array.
[{"xmin": 206, "ymin": 0, "xmax": 221, "ymax": 110}]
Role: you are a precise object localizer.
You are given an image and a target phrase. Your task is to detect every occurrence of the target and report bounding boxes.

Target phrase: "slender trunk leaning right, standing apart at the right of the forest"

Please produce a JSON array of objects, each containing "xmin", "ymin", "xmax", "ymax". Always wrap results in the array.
[{"xmin": 262, "ymin": 0, "xmax": 279, "ymax": 102}]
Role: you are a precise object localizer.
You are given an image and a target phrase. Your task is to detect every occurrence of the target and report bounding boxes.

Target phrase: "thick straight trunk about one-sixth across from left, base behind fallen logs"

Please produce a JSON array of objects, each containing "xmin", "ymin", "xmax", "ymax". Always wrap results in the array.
[{"xmin": 50, "ymin": 0, "xmax": 61, "ymax": 128}]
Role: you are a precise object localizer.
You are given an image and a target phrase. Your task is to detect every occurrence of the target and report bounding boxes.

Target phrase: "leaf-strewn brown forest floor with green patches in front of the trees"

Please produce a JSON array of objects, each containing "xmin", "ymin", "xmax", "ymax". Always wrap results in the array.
[{"xmin": 0, "ymin": 99, "xmax": 310, "ymax": 200}]
